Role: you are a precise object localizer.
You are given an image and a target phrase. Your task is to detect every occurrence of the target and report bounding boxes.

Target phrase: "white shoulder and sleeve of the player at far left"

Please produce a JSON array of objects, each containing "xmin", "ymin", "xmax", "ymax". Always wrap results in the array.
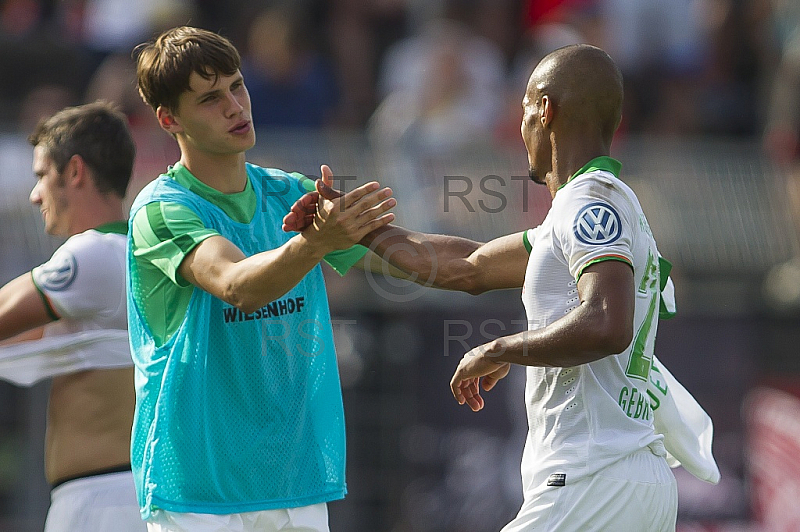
[{"xmin": 32, "ymin": 231, "xmax": 125, "ymax": 320}]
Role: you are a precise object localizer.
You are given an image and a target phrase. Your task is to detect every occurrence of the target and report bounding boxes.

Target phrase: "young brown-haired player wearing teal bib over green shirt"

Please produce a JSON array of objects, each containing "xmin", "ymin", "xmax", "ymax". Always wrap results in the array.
[{"xmin": 128, "ymin": 27, "xmax": 394, "ymax": 532}]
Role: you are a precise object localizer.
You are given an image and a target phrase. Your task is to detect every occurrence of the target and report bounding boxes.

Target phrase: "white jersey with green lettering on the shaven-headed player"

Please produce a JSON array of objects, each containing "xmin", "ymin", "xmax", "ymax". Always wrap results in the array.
[{"xmin": 522, "ymin": 157, "xmax": 664, "ymax": 498}]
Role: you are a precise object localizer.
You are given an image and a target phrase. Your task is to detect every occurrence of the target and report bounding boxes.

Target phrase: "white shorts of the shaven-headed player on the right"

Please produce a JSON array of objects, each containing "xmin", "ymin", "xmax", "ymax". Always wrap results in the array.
[{"xmin": 501, "ymin": 449, "xmax": 678, "ymax": 532}]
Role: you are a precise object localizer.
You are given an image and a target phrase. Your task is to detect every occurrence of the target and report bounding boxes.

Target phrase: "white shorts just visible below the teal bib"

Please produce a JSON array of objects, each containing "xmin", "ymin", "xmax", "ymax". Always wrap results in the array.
[{"xmin": 147, "ymin": 502, "xmax": 330, "ymax": 532}]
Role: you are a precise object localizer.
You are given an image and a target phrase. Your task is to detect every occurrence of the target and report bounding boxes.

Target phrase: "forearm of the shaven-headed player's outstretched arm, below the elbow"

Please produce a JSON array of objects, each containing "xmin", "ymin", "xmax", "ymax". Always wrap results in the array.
[{"xmin": 361, "ymin": 225, "xmax": 482, "ymax": 293}]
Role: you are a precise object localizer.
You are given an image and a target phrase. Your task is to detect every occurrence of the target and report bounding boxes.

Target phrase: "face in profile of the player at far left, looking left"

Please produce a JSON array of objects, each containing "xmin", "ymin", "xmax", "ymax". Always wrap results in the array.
[{"xmin": 30, "ymin": 146, "xmax": 69, "ymax": 235}]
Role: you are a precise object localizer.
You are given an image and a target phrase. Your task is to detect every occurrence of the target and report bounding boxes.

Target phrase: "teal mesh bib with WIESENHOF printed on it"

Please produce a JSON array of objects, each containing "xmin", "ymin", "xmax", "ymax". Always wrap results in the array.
[{"xmin": 128, "ymin": 165, "xmax": 346, "ymax": 518}]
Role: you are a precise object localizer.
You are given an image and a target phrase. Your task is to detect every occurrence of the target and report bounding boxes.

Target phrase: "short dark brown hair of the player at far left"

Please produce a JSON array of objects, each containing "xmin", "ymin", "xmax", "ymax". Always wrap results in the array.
[{"xmin": 28, "ymin": 101, "xmax": 136, "ymax": 198}]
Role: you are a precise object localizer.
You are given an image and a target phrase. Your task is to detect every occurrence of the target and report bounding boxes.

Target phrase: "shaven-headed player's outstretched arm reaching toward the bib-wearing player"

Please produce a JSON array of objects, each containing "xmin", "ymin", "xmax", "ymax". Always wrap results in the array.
[{"xmin": 361, "ymin": 226, "xmax": 528, "ymax": 294}]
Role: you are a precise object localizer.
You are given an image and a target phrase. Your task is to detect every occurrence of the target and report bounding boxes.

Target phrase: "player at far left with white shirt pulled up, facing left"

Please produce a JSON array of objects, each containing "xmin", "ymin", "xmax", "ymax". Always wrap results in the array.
[{"xmin": 0, "ymin": 102, "xmax": 145, "ymax": 532}]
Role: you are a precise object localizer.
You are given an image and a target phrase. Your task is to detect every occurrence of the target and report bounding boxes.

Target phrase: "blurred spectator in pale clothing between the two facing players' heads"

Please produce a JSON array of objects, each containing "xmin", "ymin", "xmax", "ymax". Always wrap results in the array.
[{"xmin": 370, "ymin": 20, "xmax": 504, "ymax": 156}]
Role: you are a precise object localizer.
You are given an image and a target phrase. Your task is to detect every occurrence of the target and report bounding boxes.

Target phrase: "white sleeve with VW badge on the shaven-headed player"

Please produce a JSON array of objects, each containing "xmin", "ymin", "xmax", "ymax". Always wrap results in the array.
[{"xmin": 551, "ymin": 177, "xmax": 634, "ymax": 279}]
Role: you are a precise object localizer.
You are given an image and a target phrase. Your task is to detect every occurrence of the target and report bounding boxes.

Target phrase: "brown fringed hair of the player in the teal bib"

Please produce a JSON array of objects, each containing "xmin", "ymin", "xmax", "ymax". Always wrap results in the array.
[{"xmin": 134, "ymin": 26, "xmax": 242, "ymax": 112}]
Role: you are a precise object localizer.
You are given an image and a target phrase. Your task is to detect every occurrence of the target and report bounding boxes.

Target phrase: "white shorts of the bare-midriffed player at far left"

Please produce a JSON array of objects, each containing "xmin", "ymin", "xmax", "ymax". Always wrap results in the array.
[{"xmin": 44, "ymin": 471, "xmax": 147, "ymax": 532}]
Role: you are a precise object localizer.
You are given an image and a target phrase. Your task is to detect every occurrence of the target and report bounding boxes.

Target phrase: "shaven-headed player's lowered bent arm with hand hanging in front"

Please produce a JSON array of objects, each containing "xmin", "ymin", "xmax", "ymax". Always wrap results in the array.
[{"xmin": 450, "ymin": 260, "xmax": 635, "ymax": 410}]
